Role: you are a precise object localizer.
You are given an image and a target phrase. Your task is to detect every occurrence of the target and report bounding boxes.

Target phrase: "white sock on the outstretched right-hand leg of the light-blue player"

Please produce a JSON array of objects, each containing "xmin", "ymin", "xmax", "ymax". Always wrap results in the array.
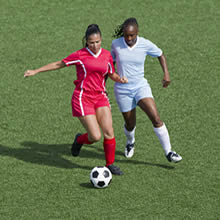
[{"xmin": 154, "ymin": 123, "xmax": 171, "ymax": 155}]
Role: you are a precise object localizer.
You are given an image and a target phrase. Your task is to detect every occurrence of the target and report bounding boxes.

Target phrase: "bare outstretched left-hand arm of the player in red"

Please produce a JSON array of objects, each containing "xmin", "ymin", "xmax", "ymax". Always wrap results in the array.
[{"xmin": 24, "ymin": 61, "xmax": 66, "ymax": 77}]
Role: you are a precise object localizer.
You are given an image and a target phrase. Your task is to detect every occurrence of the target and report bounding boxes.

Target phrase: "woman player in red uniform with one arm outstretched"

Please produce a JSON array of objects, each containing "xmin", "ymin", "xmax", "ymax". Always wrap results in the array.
[{"xmin": 24, "ymin": 24, "xmax": 127, "ymax": 175}]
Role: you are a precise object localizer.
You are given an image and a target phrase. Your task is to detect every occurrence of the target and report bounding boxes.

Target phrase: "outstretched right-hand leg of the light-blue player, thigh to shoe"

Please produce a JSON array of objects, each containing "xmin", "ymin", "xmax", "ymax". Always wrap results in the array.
[{"xmin": 138, "ymin": 98, "xmax": 182, "ymax": 162}]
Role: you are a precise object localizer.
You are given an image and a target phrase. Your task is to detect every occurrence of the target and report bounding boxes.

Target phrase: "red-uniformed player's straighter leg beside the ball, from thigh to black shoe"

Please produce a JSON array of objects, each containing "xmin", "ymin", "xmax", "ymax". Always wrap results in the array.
[{"xmin": 96, "ymin": 106, "xmax": 123, "ymax": 175}]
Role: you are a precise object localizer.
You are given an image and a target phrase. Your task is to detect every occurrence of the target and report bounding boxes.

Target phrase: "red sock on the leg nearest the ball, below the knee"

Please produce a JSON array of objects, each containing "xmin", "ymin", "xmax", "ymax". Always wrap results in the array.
[{"xmin": 103, "ymin": 137, "xmax": 116, "ymax": 166}]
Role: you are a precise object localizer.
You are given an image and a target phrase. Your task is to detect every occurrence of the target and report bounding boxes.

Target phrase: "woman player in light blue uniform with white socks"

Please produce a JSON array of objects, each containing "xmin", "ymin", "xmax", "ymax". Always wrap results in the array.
[{"xmin": 111, "ymin": 18, "xmax": 182, "ymax": 162}]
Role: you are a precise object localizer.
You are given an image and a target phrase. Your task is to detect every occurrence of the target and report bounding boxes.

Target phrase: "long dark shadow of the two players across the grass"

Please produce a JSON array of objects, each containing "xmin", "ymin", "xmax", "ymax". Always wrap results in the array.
[{"xmin": 0, "ymin": 142, "xmax": 174, "ymax": 170}]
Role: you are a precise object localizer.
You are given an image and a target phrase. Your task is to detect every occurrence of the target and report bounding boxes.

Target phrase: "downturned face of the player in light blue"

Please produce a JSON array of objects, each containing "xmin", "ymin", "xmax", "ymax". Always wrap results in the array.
[{"xmin": 123, "ymin": 25, "xmax": 138, "ymax": 47}]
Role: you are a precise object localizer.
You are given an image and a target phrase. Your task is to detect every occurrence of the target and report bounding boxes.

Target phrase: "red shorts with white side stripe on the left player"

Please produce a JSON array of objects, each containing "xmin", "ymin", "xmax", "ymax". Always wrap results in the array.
[{"xmin": 72, "ymin": 90, "xmax": 110, "ymax": 117}]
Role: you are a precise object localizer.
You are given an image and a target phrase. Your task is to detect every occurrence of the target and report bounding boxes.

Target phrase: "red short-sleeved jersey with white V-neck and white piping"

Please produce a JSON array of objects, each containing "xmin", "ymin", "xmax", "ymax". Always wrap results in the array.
[{"xmin": 62, "ymin": 48, "xmax": 115, "ymax": 93}]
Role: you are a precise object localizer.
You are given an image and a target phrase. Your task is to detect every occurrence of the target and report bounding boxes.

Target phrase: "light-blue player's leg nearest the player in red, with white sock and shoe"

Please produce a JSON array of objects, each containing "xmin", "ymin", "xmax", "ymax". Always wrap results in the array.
[{"xmin": 122, "ymin": 108, "xmax": 136, "ymax": 158}]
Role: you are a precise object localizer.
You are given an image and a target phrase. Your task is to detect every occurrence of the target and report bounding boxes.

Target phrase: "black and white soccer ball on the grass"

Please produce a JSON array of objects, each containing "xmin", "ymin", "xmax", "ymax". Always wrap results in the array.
[{"xmin": 90, "ymin": 166, "xmax": 112, "ymax": 188}]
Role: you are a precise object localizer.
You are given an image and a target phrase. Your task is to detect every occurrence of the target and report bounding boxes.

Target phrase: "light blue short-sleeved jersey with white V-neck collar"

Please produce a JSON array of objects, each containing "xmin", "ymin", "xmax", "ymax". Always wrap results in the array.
[{"xmin": 111, "ymin": 36, "xmax": 162, "ymax": 89}]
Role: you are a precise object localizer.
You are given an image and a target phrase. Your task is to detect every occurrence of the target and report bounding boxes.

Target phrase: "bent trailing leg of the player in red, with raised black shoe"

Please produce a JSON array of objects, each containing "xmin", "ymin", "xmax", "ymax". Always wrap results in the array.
[{"xmin": 71, "ymin": 115, "xmax": 101, "ymax": 156}]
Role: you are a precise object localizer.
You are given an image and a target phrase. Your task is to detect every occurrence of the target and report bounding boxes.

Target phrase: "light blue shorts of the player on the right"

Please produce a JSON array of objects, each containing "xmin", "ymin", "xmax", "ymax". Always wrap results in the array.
[{"xmin": 114, "ymin": 83, "xmax": 153, "ymax": 112}]
